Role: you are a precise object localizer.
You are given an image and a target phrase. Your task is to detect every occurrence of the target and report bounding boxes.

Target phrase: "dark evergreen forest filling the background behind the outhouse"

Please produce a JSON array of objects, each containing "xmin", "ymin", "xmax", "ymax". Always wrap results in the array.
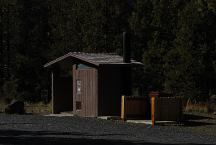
[{"xmin": 0, "ymin": 0, "xmax": 216, "ymax": 102}]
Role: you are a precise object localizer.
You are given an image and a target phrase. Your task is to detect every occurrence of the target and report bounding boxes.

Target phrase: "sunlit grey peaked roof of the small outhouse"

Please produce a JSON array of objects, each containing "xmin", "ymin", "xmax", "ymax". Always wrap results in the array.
[{"xmin": 44, "ymin": 52, "xmax": 142, "ymax": 67}]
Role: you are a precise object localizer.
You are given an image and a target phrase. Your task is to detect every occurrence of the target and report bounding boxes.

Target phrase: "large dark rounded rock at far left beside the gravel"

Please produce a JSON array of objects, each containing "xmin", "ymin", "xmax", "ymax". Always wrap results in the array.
[{"xmin": 5, "ymin": 100, "xmax": 25, "ymax": 114}]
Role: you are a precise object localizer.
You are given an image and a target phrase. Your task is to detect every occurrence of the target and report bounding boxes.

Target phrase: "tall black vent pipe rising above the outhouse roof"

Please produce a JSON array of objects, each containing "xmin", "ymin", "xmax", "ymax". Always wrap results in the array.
[{"xmin": 123, "ymin": 32, "xmax": 131, "ymax": 63}]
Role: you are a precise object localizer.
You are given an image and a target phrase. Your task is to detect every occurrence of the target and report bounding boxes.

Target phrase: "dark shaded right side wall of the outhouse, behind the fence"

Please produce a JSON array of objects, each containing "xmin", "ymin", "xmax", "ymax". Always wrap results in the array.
[{"xmin": 98, "ymin": 65, "xmax": 131, "ymax": 116}]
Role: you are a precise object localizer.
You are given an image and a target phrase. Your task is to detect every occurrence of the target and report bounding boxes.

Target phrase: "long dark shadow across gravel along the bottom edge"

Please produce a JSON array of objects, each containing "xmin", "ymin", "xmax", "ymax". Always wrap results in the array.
[{"xmin": 0, "ymin": 130, "xmax": 214, "ymax": 145}]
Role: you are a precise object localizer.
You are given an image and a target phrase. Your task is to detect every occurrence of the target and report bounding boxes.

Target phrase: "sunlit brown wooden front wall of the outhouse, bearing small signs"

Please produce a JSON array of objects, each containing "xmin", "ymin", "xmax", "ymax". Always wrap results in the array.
[{"xmin": 73, "ymin": 65, "xmax": 98, "ymax": 117}]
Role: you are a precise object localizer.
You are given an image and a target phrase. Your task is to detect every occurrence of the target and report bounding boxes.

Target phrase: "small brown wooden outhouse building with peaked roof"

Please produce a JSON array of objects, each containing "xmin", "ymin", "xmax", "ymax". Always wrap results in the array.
[{"xmin": 44, "ymin": 52, "xmax": 141, "ymax": 117}]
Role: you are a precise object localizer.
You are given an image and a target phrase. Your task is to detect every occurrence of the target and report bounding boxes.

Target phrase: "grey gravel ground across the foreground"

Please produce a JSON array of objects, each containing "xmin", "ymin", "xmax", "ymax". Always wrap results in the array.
[{"xmin": 0, "ymin": 114, "xmax": 216, "ymax": 145}]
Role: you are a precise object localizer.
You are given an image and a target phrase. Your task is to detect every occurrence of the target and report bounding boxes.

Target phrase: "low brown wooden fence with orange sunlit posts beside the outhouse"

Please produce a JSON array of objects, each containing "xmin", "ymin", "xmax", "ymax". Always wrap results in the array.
[{"xmin": 121, "ymin": 92, "xmax": 182, "ymax": 125}]
